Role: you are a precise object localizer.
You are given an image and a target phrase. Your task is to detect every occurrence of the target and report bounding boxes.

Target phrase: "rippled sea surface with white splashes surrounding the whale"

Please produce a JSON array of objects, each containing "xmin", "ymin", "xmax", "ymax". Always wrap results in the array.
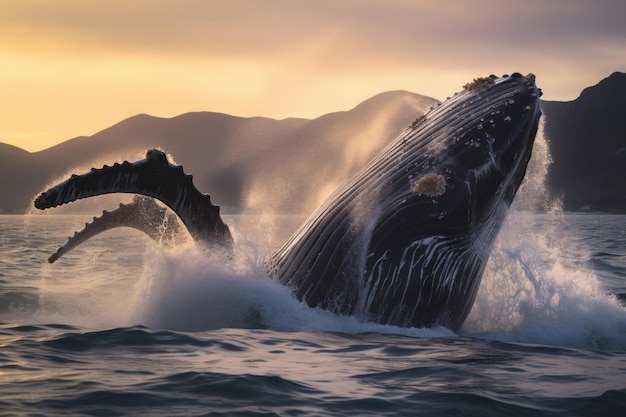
[{"xmin": 0, "ymin": 211, "xmax": 626, "ymax": 417}]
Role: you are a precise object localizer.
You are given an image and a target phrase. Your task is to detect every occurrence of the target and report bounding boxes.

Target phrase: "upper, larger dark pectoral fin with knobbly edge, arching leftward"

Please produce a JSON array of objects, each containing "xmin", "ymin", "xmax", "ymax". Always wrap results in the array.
[{"xmin": 34, "ymin": 149, "xmax": 233, "ymax": 251}]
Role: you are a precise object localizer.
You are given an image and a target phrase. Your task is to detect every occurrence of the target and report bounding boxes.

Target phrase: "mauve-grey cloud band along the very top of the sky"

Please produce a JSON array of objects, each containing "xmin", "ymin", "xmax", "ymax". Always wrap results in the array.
[{"xmin": 6, "ymin": 0, "xmax": 626, "ymax": 62}]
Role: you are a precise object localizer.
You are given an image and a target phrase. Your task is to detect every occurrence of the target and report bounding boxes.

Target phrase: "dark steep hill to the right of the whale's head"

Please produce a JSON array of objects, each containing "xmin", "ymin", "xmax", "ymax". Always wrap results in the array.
[{"xmin": 542, "ymin": 72, "xmax": 626, "ymax": 213}]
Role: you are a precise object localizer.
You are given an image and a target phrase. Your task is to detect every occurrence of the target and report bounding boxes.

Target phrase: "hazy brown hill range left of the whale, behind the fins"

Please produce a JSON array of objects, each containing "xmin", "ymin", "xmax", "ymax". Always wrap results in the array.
[{"xmin": 0, "ymin": 91, "xmax": 438, "ymax": 213}]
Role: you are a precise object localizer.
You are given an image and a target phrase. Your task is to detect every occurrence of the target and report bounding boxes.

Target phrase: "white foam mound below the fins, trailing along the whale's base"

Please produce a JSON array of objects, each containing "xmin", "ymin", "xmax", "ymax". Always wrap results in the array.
[{"xmin": 125, "ymin": 240, "xmax": 453, "ymax": 337}]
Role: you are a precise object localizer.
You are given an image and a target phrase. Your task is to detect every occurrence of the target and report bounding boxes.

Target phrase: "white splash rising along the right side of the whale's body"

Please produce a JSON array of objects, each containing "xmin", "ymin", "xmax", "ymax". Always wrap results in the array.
[{"xmin": 462, "ymin": 121, "xmax": 626, "ymax": 350}]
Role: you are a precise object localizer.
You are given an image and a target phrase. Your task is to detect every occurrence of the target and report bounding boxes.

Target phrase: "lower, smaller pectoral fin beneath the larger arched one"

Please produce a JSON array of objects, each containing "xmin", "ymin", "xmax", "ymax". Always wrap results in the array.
[{"xmin": 48, "ymin": 196, "xmax": 182, "ymax": 263}]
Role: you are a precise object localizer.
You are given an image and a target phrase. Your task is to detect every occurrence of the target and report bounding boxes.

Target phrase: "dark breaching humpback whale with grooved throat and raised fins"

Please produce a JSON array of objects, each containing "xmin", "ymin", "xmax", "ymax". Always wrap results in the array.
[{"xmin": 34, "ymin": 73, "xmax": 541, "ymax": 330}]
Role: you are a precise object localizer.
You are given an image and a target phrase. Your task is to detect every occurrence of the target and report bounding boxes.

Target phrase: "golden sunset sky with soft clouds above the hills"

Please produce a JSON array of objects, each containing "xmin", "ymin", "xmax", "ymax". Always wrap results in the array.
[{"xmin": 0, "ymin": 0, "xmax": 626, "ymax": 152}]
